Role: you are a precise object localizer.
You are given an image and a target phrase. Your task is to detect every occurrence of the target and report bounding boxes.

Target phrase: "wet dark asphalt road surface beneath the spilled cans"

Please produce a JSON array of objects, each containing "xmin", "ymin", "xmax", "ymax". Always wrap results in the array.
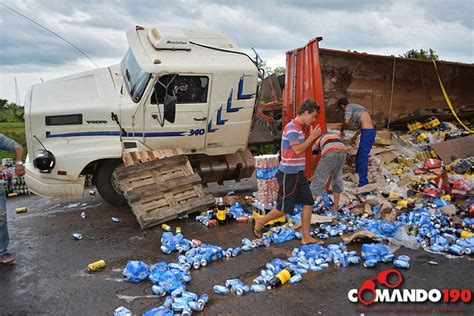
[{"xmin": 0, "ymin": 189, "xmax": 474, "ymax": 315}]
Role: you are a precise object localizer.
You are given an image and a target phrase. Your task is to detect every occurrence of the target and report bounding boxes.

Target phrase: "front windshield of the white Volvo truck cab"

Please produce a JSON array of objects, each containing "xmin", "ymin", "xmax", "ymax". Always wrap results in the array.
[{"xmin": 120, "ymin": 49, "xmax": 150, "ymax": 103}]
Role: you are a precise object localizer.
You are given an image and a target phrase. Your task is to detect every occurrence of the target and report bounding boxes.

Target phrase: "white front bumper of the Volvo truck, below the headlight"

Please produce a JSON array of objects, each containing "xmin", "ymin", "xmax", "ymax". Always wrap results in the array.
[{"xmin": 25, "ymin": 163, "xmax": 86, "ymax": 199}]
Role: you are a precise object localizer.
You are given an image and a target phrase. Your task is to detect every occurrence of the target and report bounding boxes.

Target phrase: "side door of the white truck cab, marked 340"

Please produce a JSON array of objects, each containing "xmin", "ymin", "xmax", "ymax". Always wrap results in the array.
[{"xmin": 143, "ymin": 74, "xmax": 211, "ymax": 152}]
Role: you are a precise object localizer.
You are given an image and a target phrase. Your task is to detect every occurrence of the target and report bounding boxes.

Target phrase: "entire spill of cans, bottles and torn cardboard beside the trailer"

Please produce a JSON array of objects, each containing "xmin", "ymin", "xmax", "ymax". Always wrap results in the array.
[{"xmin": 109, "ymin": 113, "xmax": 474, "ymax": 313}]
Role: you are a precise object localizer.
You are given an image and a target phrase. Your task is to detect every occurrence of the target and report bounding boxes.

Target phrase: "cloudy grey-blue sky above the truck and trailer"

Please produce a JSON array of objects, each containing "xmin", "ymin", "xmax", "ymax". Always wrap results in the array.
[{"xmin": 0, "ymin": 0, "xmax": 474, "ymax": 104}]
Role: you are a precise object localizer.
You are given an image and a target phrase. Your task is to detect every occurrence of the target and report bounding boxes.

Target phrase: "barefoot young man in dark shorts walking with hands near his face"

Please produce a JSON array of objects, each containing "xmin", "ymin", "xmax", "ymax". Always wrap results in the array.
[{"xmin": 253, "ymin": 99, "xmax": 322, "ymax": 245}]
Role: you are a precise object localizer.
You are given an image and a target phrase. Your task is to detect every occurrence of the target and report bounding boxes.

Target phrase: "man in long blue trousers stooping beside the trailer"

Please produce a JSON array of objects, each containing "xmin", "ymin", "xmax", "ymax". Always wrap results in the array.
[{"xmin": 337, "ymin": 98, "xmax": 375, "ymax": 187}]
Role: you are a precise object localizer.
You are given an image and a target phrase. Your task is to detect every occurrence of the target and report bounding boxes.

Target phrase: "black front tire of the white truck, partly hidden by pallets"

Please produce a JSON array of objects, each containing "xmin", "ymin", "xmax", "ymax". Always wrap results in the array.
[{"xmin": 95, "ymin": 159, "xmax": 127, "ymax": 206}]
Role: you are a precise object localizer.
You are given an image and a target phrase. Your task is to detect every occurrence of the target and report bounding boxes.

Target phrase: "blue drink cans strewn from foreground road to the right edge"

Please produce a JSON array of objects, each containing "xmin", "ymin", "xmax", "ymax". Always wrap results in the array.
[{"xmin": 115, "ymin": 185, "xmax": 474, "ymax": 315}]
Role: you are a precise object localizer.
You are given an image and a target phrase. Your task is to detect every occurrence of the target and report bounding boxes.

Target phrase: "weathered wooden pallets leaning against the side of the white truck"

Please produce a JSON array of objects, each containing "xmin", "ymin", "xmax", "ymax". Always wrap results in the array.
[{"xmin": 114, "ymin": 149, "xmax": 215, "ymax": 228}]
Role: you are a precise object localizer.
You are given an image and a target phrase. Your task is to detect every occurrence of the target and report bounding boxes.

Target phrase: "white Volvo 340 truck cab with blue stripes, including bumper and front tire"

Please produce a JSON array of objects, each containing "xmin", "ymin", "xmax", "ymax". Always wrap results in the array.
[{"xmin": 25, "ymin": 26, "xmax": 258, "ymax": 205}]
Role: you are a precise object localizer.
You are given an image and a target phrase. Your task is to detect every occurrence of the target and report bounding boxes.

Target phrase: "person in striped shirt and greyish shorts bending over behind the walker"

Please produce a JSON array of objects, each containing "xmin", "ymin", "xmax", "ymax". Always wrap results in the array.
[{"xmin": 311, "ymin": 133, "xmax": 347, "ymax": 213}]
